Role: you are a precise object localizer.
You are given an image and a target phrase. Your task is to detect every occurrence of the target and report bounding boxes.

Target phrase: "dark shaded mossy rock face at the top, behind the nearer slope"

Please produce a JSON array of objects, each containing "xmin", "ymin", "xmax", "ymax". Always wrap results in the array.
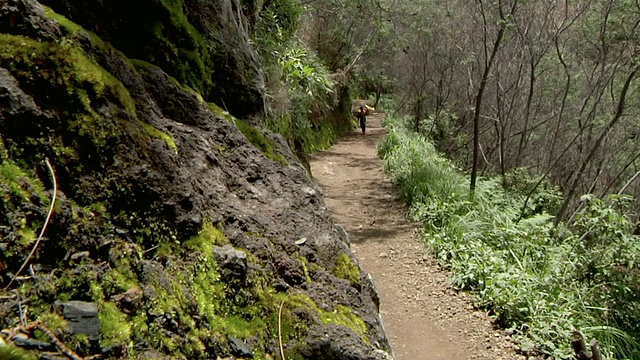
[{"xmin": 42, "ymin": 0, "xmax": 264, "ymax": 118}]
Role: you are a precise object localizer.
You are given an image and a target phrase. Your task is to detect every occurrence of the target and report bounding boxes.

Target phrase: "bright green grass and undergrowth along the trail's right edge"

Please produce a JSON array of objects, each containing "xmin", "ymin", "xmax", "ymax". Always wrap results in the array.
[{"xmin": 378, "ymin": 118, "xmax": 640, "ymax": 359}]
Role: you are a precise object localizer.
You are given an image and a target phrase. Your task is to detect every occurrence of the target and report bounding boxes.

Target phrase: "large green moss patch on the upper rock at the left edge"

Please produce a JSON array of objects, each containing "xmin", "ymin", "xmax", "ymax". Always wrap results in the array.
[{"xmin": 0, "ymin": 34, "xmax": 136, "ymax": 166}]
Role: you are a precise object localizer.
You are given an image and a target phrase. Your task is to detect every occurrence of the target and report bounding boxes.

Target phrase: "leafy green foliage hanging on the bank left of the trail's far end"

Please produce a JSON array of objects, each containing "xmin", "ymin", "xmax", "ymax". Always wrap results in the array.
[{"xmin": 253, "ymin": 0, "xmax": 349, "ymax": 157}]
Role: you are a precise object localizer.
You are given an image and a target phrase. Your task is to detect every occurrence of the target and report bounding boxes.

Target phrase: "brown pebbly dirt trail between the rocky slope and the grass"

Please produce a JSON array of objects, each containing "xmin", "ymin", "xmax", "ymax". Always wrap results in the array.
[{"xmin": 311, "ymin": 115, "xmax": 525, "ymax": 360}]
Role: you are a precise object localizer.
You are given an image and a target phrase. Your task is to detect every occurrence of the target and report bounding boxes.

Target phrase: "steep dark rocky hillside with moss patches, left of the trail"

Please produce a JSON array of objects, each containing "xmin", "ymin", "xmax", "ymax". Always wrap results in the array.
[{"xmin": 0, "ymin": 0, "xmax": 390, "ymax": 360}]
